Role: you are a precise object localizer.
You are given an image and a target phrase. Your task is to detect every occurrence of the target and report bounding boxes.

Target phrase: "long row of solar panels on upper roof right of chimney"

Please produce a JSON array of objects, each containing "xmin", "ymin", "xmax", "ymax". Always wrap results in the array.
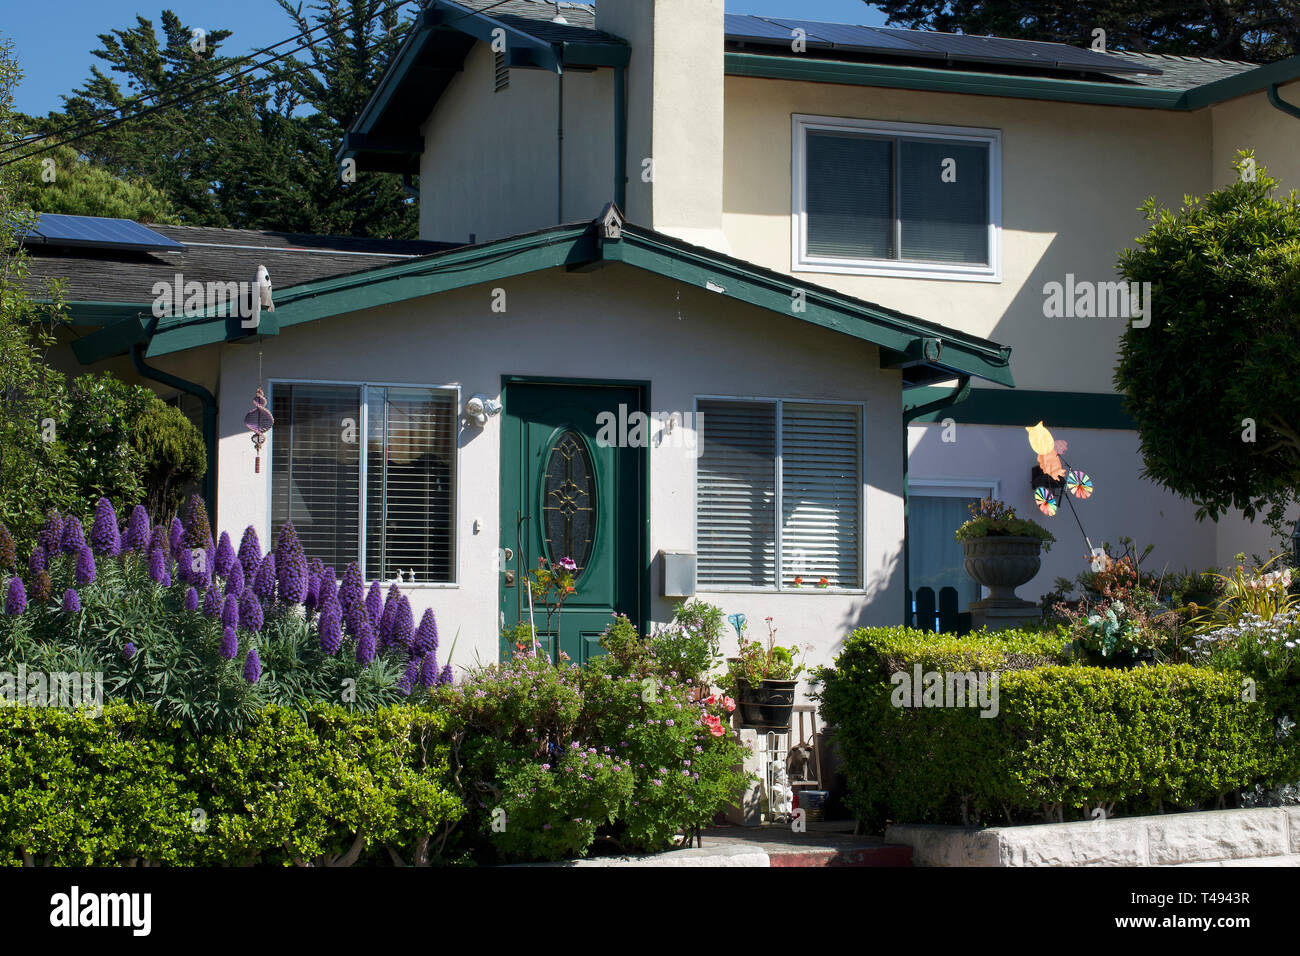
[{"xmin": 725, "ymin": 14, "xmax": 1158, "ymax": 73}]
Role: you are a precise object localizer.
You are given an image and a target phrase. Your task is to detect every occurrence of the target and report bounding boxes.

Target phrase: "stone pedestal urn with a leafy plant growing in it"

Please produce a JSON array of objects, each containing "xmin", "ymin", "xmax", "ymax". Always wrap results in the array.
[{"xmin": 956, "ymin": 498, "xmax": 1056, "ymax": 627}]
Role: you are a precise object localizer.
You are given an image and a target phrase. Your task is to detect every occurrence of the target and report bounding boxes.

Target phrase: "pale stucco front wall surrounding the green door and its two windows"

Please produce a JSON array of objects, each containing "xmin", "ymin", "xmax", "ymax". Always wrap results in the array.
[{"xmin": 217, "ymin": 265, "xmax": 902, "ymax": 686}]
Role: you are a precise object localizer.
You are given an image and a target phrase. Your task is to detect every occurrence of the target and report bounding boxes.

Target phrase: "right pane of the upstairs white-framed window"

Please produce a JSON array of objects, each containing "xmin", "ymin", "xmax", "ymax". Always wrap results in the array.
[{"xmin": 898, "ymin": 139, "xmax": 988, "ymax": 264}]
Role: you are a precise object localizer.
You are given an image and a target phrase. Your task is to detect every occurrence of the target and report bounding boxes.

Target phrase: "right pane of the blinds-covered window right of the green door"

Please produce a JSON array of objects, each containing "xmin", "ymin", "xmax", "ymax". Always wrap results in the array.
[{"xmin": 780, "ymin": 402, "xmax": 862, "ymax": 588}]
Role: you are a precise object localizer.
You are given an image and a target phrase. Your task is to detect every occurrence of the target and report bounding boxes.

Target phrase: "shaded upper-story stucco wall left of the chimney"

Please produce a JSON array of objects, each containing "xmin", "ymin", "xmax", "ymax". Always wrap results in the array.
[{"xmin": 420, "ymin": 43, "xmax": 614, "ymax": 242}]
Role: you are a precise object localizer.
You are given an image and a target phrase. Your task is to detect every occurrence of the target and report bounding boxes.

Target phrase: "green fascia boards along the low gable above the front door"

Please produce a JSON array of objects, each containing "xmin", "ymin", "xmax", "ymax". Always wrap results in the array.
[{"xmin": 147, "ymin": 222, "xmax": 1014, "ymax": 386}]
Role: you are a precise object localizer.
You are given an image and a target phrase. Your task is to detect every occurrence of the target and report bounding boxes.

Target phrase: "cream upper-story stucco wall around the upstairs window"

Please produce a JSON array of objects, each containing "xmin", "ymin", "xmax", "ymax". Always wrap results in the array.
[{"xmin": 723, "ymin": 77, "xmax": 1212, "ymax": 392}]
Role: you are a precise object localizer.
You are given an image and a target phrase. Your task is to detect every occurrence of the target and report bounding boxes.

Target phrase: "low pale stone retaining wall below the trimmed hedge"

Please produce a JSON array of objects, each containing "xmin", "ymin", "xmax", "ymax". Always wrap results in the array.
[{"xmin": 885, "ymin": 806, "xmax": 1300, "ymax": 866}]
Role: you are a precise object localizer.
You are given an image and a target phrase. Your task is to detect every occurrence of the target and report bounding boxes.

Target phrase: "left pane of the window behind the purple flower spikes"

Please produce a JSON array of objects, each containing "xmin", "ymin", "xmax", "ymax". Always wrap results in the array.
[{"xmin": 268, "ymin": 385, "xmax": 361, "ymax": 568}]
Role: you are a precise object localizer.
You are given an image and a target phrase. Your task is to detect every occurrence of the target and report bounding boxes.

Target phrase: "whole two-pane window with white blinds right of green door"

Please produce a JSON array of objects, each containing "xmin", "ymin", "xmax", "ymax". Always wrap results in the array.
[{"xmin": 696, "ymin": 399, "xmax": 862, "ymax": 589}]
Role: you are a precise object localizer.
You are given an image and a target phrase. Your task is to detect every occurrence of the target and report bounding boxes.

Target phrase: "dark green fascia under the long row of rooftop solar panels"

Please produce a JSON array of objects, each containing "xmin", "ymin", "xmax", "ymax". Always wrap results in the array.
[{"xmin": 725, "ymin": 53, "xmax": 1184, "ymax": 109}]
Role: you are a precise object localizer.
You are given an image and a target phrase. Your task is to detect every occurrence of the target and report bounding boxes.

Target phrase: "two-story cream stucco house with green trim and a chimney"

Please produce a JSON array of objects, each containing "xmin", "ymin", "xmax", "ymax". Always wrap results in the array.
[{"xmin": 53, "ymin": 0, "xmax": 1300, "ymax": 681}]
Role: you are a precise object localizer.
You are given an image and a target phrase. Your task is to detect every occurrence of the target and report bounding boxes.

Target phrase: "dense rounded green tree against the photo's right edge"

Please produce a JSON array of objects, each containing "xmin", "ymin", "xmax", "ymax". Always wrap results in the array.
[{"xmin": 1115, "ymin": 151, "xmax": 1300, "ymax": 535}]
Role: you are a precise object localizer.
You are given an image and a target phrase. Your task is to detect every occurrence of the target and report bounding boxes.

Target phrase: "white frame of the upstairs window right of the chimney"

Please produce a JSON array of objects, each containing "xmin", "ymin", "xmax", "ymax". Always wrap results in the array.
[{"xmin": 790, "ymin": 113, "xmax": 1002, "ymax": 282}]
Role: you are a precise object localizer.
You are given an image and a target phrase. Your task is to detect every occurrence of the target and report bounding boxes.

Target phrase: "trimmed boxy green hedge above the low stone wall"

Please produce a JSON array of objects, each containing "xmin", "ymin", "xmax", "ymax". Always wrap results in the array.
[{"xmin": 819, "ymin": 628, "xmax": 1300, "ymax": 826}]
